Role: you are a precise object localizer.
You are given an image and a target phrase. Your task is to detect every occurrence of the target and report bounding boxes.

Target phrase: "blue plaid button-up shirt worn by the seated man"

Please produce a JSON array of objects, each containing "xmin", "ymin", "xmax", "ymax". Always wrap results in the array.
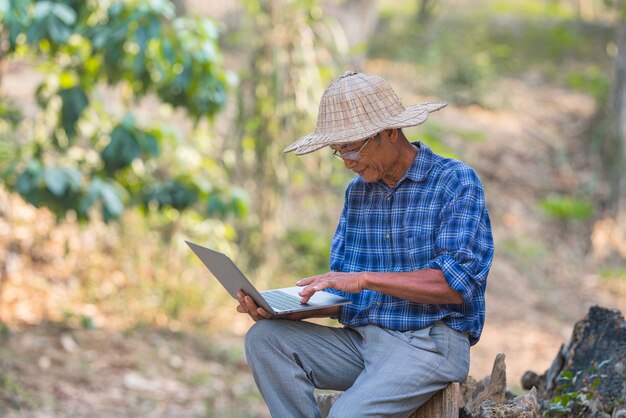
[{"xmin": 327, "ymin": 143, "xmax": 494, "ymax": 345}]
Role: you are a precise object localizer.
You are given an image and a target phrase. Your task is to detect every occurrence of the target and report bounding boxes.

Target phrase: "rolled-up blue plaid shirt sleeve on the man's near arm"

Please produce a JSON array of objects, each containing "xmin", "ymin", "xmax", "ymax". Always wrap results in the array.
[{"xmin": 429, "ymin": 173, "xmax": 494, "ymax": 303}]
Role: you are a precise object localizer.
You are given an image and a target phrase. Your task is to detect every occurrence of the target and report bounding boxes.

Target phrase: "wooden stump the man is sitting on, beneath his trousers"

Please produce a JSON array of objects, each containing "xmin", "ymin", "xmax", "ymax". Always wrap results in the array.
[{"xmin": 315, "ymin": 382, "xmax": 461, "ymax": 418}]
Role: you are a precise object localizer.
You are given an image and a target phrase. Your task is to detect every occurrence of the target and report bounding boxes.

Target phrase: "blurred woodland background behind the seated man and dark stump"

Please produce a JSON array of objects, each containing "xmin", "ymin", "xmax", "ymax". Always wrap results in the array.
[{"xmin": 0, "ymin": 0, "xmax": 626, "ymax": 417}]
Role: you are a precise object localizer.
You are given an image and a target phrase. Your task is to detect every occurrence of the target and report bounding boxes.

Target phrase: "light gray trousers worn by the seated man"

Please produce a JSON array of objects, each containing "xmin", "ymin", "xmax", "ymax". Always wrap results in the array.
[{"xmin": 245, "ymin": 319, "xmax": 470, "ymax": 418}]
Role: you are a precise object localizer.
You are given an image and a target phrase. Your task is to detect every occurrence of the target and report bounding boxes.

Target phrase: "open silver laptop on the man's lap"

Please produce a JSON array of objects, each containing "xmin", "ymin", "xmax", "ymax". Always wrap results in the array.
[{"xmin": 185, "ymin": 241, "xmax": 352, "ymax": 315}]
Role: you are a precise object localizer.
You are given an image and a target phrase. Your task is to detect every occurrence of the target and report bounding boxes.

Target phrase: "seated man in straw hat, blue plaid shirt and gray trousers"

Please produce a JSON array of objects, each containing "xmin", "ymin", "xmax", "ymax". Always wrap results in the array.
[{"xmin": 237, "ymin": 72, "xmax": 494, "ymax": 418}]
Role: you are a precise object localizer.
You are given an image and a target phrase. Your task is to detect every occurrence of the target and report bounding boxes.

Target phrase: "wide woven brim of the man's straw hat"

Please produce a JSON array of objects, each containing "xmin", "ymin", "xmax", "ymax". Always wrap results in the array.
[{"xmin": 284, "ymin": 102, "xmax": 448, "ymax": 155}]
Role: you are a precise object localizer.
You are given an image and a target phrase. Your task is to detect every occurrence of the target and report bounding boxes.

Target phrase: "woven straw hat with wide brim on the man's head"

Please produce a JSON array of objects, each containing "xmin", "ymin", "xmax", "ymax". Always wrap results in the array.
[{"xmin": 285, "ymin": 71, "xmax": 447, "ymax": 155}]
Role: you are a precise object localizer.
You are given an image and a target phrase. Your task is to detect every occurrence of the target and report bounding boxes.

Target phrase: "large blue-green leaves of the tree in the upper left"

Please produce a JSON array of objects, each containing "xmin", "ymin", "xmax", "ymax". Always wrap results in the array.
[{"xmin": 0, "ymin": 0, "xmax": 241, "ymax": 221}]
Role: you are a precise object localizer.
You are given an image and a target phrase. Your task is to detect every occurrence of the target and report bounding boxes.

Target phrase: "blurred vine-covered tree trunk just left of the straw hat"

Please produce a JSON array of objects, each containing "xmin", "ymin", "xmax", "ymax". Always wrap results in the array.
[{"xmin": 232, "ymin": 0, "xmax": 333, "ymax": 280}]
